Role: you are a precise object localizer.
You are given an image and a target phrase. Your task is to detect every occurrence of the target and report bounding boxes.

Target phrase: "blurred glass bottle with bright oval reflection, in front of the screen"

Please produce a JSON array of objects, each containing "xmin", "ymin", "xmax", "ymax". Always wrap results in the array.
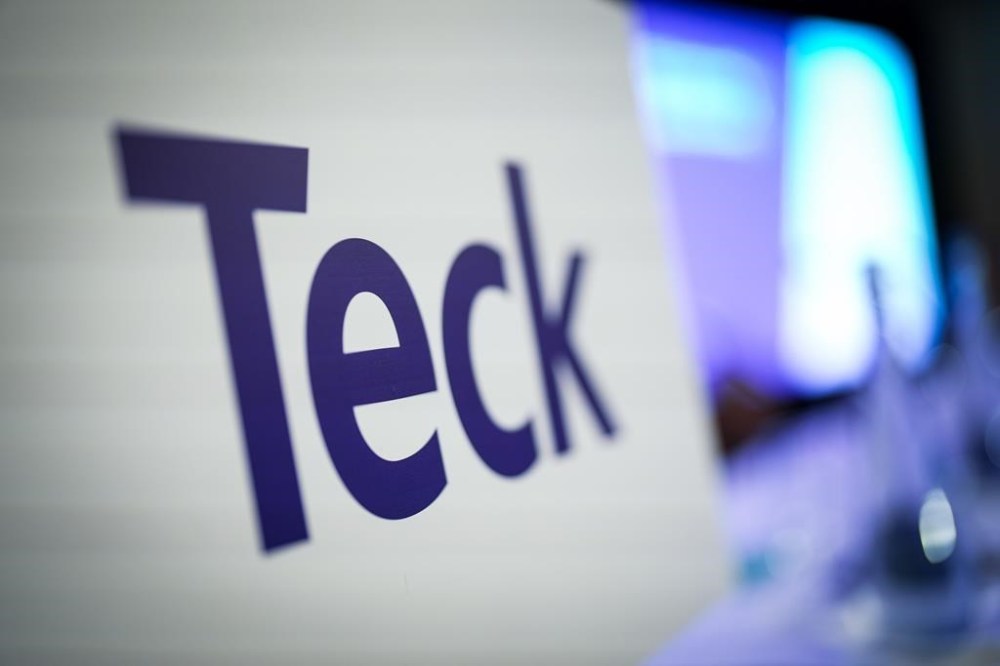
[{"xmin": 864, "ymin": 267, "xmax": 975, "ymax": 644}]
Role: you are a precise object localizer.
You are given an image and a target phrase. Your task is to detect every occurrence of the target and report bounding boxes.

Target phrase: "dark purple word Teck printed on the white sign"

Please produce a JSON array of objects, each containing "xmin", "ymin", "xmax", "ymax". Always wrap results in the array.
[{"xmin": 116, "ymin": 129, "xmax": 615, "ymax": 551}]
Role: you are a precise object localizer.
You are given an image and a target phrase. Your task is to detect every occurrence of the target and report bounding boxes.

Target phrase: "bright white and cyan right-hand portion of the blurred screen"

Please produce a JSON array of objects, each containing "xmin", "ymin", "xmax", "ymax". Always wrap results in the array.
[{"xmin": 779, "ymin": 20, "xmax": 942, "ymax": 391}]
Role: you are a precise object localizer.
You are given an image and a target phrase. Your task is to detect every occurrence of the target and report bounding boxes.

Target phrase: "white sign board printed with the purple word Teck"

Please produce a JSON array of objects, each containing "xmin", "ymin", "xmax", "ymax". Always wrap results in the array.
[{"xmin": 0, "ymin": 0, "xmax": 726, "ymax": 664}]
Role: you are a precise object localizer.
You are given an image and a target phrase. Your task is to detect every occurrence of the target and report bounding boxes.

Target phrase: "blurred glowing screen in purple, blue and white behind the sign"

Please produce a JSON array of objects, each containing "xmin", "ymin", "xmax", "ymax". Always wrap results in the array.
[{"xmin": 634, "ymin": 2, "xmax": 944, "ymax": 396}]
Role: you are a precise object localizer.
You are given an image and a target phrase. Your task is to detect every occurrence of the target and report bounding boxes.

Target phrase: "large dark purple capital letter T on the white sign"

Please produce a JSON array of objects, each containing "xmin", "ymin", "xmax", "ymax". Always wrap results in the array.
[{"xmin": 116, "ymin": 128, "xmax": 309, "ymax": 551}]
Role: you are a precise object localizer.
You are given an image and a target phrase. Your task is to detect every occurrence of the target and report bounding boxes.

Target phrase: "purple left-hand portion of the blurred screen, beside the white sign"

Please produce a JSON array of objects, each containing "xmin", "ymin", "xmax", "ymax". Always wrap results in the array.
[{"xmin": 638, "ymin": 7, "xmax": 788, "ymax": 394}]
